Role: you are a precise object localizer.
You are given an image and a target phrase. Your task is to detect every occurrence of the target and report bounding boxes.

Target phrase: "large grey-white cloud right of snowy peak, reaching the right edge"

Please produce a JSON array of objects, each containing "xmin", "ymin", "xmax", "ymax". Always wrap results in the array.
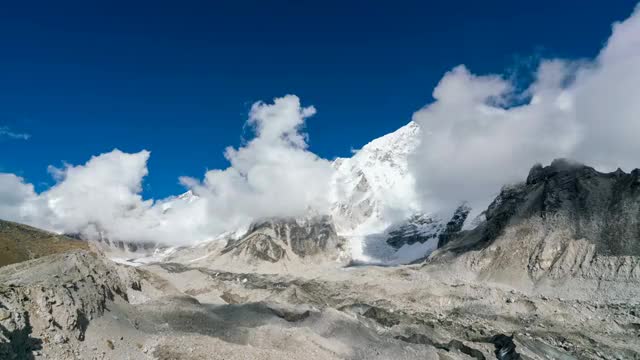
[{"xmin": 411, "ymin": 4, "xmax": 640, "ymax": 211}]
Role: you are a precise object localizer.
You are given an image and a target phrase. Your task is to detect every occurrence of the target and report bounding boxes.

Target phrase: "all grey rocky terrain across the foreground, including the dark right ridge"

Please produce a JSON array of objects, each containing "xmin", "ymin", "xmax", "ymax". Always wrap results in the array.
[{"xmin": 0, "ymin": 160, "xmax": 640, "ymax": 359}]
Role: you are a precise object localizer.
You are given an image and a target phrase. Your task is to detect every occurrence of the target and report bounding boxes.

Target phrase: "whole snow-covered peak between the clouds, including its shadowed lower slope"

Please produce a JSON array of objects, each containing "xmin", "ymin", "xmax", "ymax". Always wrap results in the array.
[{"xmin": 332, "ymin": 122, "xmax": 462, "ymax": 264}]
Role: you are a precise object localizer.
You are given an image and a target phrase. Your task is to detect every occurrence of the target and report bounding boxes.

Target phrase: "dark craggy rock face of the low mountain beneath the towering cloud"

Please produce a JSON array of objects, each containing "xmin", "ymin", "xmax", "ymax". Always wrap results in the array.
[{"xmin": 222, "ymin": 216, "xmax": 343, "ymax": 263}]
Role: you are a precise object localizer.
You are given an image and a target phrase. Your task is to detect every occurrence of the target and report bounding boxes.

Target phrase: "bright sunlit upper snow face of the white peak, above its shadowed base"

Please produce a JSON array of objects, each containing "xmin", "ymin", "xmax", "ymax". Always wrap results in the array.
[{"xmin": 331, "ymin": 122, "xmax": 420, "ymax": 234}]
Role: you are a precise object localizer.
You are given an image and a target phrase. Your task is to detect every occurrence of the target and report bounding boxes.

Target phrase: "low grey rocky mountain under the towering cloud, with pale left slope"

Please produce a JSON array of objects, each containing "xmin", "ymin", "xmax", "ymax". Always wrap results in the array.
[{"xmin": 157, "ymin": 215, "xmax": 349, "ymax": 273}]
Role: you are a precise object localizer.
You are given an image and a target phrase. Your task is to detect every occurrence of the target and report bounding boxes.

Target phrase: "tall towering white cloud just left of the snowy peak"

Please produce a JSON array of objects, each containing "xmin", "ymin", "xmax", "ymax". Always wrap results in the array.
[{"xmin": 182, "ymin": 95, "xmax": 333, "ymax": 232}]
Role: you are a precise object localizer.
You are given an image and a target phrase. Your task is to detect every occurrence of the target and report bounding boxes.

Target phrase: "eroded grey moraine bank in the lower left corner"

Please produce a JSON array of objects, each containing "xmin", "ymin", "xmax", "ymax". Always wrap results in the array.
[{"xmin": 0, "ymin": 251, "xmax": 127, "ymax": 359}]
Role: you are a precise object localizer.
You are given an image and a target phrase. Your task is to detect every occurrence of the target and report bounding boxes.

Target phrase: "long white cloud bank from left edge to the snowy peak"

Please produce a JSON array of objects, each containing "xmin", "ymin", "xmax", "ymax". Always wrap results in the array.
[{"xmin": 0, "ymin": 95, "xmax": 333, "ymax": 244}]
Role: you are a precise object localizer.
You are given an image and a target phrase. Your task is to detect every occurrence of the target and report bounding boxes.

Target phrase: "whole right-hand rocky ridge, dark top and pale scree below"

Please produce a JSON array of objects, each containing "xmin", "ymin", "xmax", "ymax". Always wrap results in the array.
[{"xmin": 430, "ymin": 159, "xmax": 640, "ymax": 281}]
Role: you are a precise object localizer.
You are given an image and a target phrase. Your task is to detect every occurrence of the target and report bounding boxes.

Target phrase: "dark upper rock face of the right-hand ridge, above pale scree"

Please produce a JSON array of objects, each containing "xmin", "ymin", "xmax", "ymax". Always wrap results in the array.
[{"xmin": 526, "ymin": 160, "xmax": 640, "ymax": 256}]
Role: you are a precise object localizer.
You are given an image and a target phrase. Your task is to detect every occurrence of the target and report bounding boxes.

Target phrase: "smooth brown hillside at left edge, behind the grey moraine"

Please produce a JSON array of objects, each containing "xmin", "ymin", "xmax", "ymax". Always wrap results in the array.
[{"xmin": 0, "ymin": 220, "xmax": 89, "ymax": 266}]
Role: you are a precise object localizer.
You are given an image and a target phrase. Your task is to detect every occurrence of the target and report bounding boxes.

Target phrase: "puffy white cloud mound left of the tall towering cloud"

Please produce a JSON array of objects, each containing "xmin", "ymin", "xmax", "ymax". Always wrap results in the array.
[{"xmin": 40, "ymin": 150, "xmax": 152, "ymax": 239}]
